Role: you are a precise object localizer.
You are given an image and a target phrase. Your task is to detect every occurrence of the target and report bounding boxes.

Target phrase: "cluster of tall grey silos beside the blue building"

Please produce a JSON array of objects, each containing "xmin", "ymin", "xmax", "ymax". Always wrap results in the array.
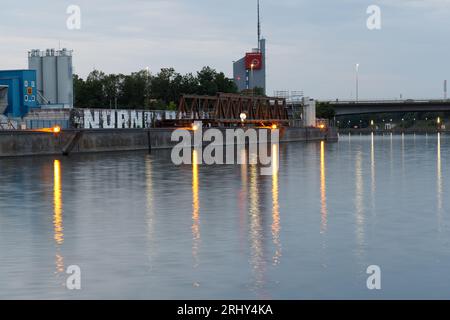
[{"xmin": 28, "ymin": 49, "xmax": 73, "ymax": 108}]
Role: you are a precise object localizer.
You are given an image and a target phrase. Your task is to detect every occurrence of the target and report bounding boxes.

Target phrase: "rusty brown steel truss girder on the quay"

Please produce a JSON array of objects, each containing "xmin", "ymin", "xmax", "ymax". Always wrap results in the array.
[{"xmin": 177, "ymin": 93, "xmax": 289, "ymax": 124}]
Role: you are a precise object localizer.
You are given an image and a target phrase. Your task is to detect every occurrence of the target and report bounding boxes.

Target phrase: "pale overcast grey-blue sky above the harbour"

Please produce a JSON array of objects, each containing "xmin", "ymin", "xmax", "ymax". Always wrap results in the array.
[{"xmin": 0, "ymin": 0, "xmax": 450, "ymax": 99}]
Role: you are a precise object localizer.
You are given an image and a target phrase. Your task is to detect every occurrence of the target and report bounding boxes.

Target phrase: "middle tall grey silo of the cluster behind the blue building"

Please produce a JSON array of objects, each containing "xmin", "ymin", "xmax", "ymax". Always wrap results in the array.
[{"xmin": 42, "ymin": 49, "xmax": 58, "ymax": 104}]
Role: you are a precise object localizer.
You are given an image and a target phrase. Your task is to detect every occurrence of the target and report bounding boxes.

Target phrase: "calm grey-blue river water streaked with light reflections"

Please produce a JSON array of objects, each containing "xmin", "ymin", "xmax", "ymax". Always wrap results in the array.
[{"xmin": 0, "ymin": 135, "xmax": 450, "ymax": 299}]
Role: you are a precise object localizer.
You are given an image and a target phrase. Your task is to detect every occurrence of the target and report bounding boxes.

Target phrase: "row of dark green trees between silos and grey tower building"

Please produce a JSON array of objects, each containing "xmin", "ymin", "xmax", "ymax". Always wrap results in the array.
[{"xmin": 74, "ymin": 67, "xmax": 238, "ymax": 110}]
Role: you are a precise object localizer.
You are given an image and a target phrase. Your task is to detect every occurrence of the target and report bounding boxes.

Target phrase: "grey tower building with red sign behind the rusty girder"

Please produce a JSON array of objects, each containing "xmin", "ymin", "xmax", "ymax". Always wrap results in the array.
[{"xmin": 233, "ymin": 39, "xmax": 266, "ymax": 93}]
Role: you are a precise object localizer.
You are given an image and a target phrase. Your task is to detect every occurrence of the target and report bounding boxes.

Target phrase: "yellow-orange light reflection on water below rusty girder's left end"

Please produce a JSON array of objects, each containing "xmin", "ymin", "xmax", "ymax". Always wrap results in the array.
[{"xmin": 192, "ymin": 149, "xmax": 200, "ymax": 268}]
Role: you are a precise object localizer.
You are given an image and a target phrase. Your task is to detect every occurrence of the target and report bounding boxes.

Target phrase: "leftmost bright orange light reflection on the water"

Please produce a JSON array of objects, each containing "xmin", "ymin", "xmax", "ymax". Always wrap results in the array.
[{"xmin": 53, "ymin": 160, "xmax": 64, "ymax": 273}]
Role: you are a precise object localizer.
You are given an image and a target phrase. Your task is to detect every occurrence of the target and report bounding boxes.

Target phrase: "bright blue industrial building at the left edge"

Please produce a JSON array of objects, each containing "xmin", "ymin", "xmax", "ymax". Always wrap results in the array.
[{"xmin": 0, "ymin": 70, "xmax": 38, "ymax": 118}]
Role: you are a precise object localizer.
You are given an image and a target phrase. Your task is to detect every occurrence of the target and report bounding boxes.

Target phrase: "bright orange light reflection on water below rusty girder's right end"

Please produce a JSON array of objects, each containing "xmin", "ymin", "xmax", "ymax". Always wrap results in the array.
[{"xmin": 272, "ymin": 144, "xmax": 281, "ymax": 265}]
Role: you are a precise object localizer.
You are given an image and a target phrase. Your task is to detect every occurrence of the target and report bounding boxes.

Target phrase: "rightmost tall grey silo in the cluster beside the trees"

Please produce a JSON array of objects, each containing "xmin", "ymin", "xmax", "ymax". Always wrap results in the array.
[{"xmin": 56, "ymin": 49, "xmax": 73, "ymax": 108}]
